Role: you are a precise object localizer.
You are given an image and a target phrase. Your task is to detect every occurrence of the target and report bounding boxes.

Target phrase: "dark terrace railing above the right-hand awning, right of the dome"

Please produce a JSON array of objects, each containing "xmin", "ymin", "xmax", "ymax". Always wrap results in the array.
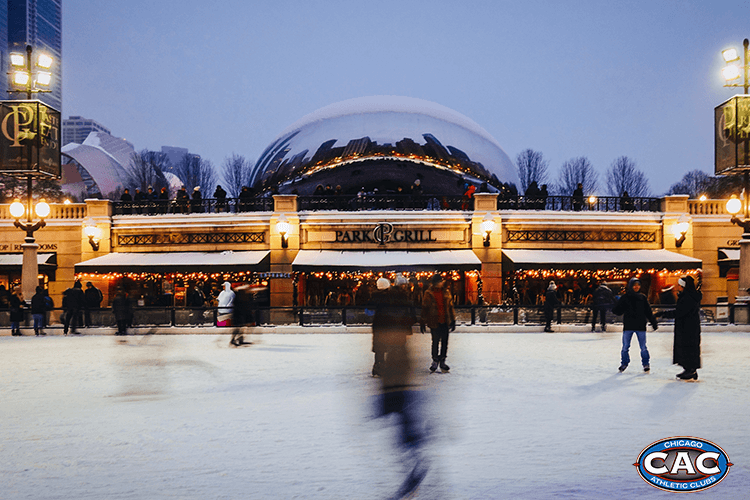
[{"xmin": 497, "ymin": 196, "xmax": 661, "ymax": 212}]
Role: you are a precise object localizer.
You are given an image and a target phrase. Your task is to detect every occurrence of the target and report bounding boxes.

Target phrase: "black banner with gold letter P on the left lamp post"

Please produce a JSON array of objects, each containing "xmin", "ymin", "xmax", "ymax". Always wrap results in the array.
[{"xmin": 0, "ymin": 101, "xmax": 61, "ymax": 178}]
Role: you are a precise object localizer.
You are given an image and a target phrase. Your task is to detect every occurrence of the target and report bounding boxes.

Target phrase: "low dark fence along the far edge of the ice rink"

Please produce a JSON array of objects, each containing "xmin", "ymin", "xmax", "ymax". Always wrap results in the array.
[{"xmin": 0, "ymin": 303, "xmax": 750, "ymax": 329}]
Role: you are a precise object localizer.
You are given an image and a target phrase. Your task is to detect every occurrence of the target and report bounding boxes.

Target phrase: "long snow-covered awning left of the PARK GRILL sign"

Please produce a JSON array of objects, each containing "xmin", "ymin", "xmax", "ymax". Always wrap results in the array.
[{"xmin": 75, "ymin": 250, "xmax": 270, "ymax": 274}]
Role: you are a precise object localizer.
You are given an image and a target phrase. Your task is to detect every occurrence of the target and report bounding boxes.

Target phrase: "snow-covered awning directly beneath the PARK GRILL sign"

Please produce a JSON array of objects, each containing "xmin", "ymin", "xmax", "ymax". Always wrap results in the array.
[{"xmin": 292, "ymin": 250, "xmax": 482, "ymax": 271}]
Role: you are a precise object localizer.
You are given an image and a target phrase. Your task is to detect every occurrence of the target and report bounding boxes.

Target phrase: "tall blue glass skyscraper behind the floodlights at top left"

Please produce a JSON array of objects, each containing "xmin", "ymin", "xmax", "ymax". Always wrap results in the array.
[{"xmin": 6, "ymin": 0, "xmax": 62, "ymax": 112}]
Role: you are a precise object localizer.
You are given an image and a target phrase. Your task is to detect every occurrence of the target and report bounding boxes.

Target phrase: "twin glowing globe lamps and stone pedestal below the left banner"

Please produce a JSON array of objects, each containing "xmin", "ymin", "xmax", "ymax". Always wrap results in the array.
[{"xmin": 10, "ymin": 197, "xmax": 50, "ymax": 302}]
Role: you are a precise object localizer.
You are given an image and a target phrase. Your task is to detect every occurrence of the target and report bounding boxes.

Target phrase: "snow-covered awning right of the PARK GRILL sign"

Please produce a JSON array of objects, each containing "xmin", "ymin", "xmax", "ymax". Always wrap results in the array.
[{"xmin": 503, "ymin": 249, "xmax": 702, "ymax": 271}]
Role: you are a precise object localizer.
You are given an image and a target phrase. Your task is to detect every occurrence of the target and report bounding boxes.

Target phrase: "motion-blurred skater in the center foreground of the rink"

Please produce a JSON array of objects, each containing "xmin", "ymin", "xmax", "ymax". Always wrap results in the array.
[{"xmin": 372, "ymin": 278, "xmax": 428, "ymax": 498}]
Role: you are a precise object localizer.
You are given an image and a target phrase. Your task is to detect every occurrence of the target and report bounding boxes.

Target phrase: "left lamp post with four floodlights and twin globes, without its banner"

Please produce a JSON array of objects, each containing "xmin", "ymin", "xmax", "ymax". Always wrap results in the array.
[{"xmin": 8, "ymin": 45, "xmax": 53, "ymax": 303}]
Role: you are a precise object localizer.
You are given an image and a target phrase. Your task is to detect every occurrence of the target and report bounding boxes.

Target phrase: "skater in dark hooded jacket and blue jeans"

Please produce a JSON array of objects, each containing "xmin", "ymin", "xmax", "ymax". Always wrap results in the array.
[{"xmin": 612, "ymin": 278, "xmax": 658, "ymax": 372}]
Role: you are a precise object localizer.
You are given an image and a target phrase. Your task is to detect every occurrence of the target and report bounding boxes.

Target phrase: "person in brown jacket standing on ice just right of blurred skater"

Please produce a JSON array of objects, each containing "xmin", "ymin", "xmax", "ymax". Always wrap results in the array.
[{"xmin": 419, "ymin": 274, "xmax": 456, "ymax": 372}]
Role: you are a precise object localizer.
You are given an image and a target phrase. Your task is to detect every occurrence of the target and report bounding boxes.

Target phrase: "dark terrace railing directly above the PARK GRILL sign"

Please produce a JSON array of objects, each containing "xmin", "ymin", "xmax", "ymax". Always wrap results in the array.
[{"xmin": 297, "ymin": 194, "xmax": 474, "ymax": 212}]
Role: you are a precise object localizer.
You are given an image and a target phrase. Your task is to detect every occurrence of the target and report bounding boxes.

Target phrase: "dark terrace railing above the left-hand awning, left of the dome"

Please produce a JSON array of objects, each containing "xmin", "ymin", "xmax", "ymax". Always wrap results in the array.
[{"xmin": 112, "ymin": 197, "xmax": 273, "ymax": 215}]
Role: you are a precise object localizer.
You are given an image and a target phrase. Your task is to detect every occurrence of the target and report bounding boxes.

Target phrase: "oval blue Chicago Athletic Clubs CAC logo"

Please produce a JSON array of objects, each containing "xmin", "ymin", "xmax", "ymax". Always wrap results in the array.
[{"xmin": 633, "ymin": 437, "xmax": 732, "ymax": 491}]
